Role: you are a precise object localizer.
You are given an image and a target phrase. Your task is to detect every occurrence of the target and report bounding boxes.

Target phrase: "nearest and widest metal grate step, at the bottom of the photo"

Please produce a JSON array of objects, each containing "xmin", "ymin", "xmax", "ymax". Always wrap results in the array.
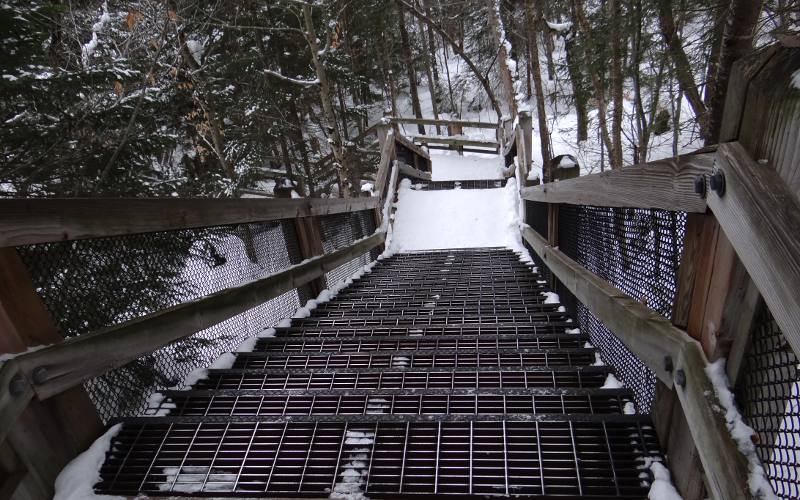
[{"xmin": 96, "ymin": 419, "xmax": 658, "ymax": 498}]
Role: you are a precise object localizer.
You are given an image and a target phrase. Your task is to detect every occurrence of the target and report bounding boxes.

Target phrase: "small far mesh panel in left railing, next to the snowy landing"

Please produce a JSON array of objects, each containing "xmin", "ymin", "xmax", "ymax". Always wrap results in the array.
[{"xmin": 320, "ymin": 210, "xmax": 377, "ymax": 288}]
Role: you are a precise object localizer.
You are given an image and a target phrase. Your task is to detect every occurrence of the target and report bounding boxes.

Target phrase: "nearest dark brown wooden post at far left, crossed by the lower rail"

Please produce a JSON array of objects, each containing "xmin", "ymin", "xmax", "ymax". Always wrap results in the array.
[{"xmin": 0, "ymin": 247, "xmax": 103, "ymax": 498}]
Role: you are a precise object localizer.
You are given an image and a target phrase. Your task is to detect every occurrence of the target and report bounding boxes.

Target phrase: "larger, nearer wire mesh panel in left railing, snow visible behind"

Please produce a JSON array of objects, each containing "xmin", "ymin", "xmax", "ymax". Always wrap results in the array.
[{"xmin": 17, "ymin": 221, "xmax": 302, "ymax": 420}]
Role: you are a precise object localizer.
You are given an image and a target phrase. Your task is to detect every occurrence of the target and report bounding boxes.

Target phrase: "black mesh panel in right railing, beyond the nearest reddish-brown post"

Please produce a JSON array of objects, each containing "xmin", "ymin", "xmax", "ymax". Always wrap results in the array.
[{"xmin": 557, "ymin": 205, "xmax": 686, "ymax": 412}]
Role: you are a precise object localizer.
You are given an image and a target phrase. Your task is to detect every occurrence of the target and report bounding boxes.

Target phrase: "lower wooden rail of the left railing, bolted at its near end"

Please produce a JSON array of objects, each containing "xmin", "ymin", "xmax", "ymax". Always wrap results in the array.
[{"xmin": 0, "ymin": 231, "xmax": 386, "ymax": 410}]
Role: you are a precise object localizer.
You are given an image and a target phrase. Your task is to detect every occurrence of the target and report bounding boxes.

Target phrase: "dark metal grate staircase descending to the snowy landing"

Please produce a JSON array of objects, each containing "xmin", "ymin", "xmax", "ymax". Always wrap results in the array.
[{"xmin": 96, "ymin": 248, "xmax": 660, "ymax": 498}]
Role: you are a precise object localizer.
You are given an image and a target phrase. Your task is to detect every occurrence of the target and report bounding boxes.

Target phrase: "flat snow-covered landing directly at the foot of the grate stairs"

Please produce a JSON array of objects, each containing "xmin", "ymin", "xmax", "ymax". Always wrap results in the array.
[{"xmin": 391, "ymin": 179, "xmax": 524, "ymax": 252}]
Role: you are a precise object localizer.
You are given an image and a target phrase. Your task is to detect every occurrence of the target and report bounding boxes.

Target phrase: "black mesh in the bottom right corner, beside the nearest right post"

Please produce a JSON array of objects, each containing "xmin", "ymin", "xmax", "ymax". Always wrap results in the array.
[{"xmin": 736, "ymin": 307, "xmax": 800, "ymax": 499}]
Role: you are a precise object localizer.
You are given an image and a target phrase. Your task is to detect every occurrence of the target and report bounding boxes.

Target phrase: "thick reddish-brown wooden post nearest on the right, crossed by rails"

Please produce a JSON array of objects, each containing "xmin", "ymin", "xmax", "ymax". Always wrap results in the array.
[{"xmin": 653, "ymin": 45, "xmax": 800, "ymax": 500}]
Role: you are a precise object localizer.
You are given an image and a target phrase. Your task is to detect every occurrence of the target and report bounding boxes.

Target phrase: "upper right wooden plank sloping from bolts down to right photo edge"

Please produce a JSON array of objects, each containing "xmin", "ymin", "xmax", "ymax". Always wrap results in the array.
[{"xmin": 708, "ymin": 143, "xmax": 800, "ymax": 360}]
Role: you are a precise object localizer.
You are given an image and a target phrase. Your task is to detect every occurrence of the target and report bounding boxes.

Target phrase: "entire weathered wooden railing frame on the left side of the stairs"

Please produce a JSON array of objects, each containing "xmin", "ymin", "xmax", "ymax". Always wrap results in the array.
[{"xmin": 0, "ymin": 124, "xmax": 418, "ymax": 498}]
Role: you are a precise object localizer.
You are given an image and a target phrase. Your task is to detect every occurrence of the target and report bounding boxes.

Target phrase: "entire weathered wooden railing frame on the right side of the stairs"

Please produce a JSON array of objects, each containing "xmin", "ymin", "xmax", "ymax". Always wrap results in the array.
[{"xmin": 512, "ymin": 43, "xmax": 800, "ymax": 499}]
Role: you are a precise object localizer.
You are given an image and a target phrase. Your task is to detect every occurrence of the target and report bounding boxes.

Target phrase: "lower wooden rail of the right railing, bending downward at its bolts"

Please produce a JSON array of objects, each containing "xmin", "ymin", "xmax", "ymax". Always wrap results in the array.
[{"xmin": 523, "ymin": 226, "xmax": 752, "ymax": 499}]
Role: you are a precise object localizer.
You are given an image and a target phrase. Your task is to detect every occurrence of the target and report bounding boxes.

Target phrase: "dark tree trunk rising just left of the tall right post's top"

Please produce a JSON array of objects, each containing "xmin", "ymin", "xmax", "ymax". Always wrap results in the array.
[{"xmin": 706, "ymin": 0, "xmax": 763, "ymax": 144}]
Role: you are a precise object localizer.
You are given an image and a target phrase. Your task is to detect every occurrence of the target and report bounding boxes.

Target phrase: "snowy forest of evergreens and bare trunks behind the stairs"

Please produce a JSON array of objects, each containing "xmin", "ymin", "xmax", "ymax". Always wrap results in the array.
[{"xmin": 0, "ymin": 0, "xmax": 800, "ymax": 197}]
